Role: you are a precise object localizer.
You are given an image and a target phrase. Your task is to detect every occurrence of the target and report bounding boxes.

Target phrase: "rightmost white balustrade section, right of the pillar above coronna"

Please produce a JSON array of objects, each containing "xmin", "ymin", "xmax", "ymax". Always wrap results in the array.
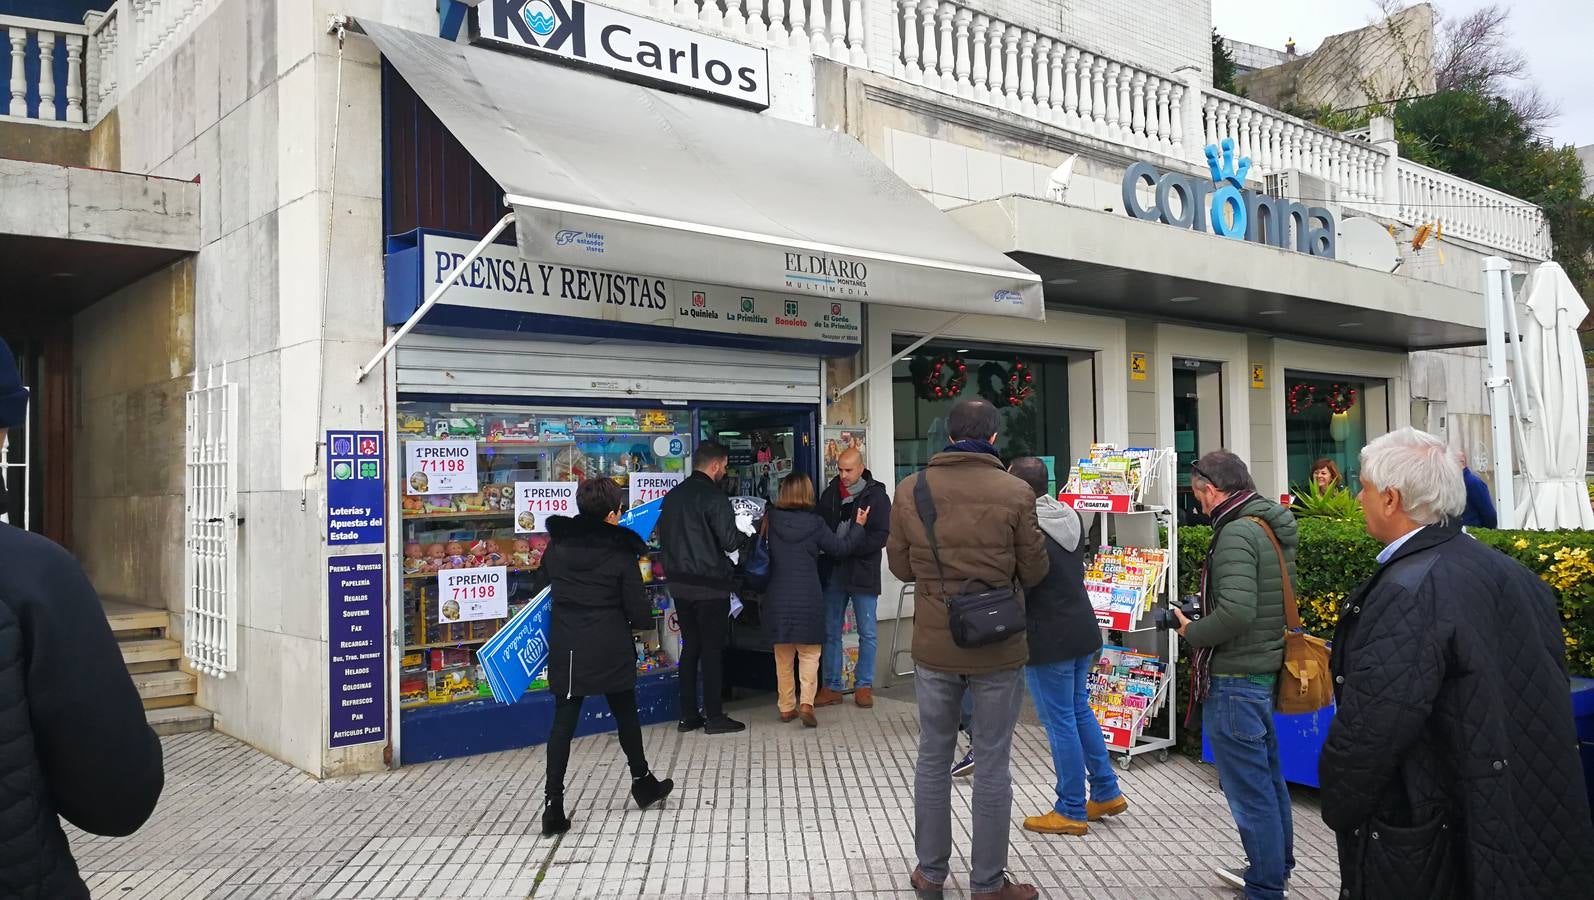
[{"xmin": 1395, "ymin": 159, "xmax": 1551, "ymax": 260}]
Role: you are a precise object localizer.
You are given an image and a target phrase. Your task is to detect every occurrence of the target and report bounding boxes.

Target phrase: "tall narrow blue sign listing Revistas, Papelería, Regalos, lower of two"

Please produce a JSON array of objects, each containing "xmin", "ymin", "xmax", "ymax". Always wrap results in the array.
[{"xmin": 327, "ymin": 553, "xmax": 387, "ymax": 747}]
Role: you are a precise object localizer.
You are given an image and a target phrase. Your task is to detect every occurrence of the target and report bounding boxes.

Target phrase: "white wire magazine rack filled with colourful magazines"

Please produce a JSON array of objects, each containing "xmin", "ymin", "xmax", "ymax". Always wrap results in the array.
[{"xmin": 1058, "ymin": 448, "xmax": 1180, "ymax": 769}]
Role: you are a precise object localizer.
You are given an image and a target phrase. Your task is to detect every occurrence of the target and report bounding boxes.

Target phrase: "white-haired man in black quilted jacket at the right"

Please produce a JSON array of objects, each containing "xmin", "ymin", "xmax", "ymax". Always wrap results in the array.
[{"xmin": 1318, "ymin": 428, "xmax": 1594, "ymax": 900}]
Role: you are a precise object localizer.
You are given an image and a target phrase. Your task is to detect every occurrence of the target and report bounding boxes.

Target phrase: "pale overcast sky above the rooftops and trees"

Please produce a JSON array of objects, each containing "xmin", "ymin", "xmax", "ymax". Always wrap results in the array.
[{"xmin": 1211, "ymin": 0, "xmax": 1594, "ymax": 147}]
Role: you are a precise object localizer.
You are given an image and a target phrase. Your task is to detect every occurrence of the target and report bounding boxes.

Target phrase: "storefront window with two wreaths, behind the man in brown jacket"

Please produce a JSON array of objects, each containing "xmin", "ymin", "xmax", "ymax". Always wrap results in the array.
[{"xmin": 891, "ymin": 344, "xmax": 1071, "ymax": 491}]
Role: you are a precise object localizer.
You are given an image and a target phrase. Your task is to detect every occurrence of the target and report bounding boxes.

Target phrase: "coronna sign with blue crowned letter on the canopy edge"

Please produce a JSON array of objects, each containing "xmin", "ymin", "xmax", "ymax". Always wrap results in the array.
[{"xmin": 1124, "ymin": 139, "xmax": 1336, "ymax": 260}]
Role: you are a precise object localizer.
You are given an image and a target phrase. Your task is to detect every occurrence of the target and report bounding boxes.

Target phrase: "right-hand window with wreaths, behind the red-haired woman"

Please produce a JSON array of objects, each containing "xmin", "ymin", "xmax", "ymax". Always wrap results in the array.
[{"xmin": 1285, "ymin": 376, "xmax": 1368, "ymax": 492}]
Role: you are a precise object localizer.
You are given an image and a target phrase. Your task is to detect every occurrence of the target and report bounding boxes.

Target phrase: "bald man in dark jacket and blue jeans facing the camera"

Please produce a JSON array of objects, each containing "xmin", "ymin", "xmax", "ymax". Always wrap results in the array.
[{"xmin": 813, "ymin": 449, "xmax": 891, "ymax": 709}]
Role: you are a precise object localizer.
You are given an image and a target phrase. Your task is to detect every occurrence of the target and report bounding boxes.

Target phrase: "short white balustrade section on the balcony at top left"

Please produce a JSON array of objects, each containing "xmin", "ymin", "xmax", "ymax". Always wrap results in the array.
[{"xmin": 0, "ymin": 16, "xmax": 88, "ymax": 123}]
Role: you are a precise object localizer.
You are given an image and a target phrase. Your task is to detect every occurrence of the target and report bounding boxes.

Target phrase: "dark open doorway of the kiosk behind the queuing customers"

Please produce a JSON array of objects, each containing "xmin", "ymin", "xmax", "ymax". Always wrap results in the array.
[{"xmin": 697, "ymin": 406, "xmax": 824, "ymax": 693}]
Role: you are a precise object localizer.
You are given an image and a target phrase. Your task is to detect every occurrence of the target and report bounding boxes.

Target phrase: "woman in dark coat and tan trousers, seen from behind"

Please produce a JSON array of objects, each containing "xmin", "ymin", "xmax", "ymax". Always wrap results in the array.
[{"xmin": 764, "ymin": 472, "xmax": 869, "ymax": 728}]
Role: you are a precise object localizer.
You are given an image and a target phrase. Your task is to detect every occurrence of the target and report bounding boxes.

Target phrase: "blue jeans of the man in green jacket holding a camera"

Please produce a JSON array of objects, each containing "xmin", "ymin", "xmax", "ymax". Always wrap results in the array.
[{"xmin": 1202, "ymin": 675, "xmax": 1294, "ymax": 900}]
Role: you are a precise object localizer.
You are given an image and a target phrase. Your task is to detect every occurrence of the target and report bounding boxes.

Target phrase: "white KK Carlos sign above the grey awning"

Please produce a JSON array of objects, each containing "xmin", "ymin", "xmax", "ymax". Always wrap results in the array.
[{"xmin": 473, "ymin": 0, "xmax": 770, "ymax": 110}]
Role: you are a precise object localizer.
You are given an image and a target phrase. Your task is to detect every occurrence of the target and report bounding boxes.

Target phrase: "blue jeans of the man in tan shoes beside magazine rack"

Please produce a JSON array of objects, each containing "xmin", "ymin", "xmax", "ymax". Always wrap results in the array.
[{"xmin": 1025, "ymin": 653, "xmax": 1124, "ymax": 822}]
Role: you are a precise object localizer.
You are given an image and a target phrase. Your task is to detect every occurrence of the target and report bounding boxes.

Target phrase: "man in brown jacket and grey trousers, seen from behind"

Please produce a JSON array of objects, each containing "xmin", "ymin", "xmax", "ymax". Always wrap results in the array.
[{"xmin": 886, "ymin": 400, "xmax": 1049, "ymax": 900}]
